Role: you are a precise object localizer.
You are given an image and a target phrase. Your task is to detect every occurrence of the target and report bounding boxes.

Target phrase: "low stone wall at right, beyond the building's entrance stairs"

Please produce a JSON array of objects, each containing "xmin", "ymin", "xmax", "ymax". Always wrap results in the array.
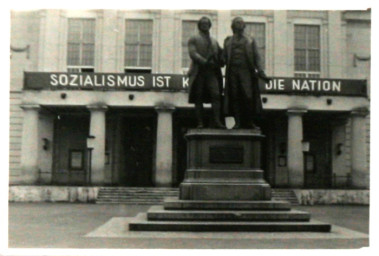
[{"xmin": 294, "ymin": 189, "xmax": 370, "ymax": 205}]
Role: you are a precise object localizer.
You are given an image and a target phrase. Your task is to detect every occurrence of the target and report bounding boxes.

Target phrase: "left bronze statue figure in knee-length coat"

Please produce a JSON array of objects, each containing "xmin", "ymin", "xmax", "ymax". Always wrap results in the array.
[{"xmin": 188, "ymin": 17, "xmax": 225, "ymax": 128}]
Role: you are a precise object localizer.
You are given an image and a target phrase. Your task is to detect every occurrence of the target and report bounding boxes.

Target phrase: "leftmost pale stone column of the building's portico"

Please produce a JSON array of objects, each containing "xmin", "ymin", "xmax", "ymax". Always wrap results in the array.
[{"xmin": 20, "ymin": 104, "xmax": 40, "ymax": 184}]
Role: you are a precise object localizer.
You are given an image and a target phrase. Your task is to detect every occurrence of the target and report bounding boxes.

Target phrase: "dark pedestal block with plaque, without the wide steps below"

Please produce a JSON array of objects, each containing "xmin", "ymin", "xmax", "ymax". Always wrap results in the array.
[{"xmin": 180, "ymin": 129, "xmax": 271, "ymax": 201}]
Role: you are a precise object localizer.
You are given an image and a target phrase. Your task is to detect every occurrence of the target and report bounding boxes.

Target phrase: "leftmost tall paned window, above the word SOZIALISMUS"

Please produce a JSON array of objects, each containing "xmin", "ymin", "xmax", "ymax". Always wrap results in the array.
[{"xmin": 67, "ymin": 19, "xmax": 95, "ymax": 72}]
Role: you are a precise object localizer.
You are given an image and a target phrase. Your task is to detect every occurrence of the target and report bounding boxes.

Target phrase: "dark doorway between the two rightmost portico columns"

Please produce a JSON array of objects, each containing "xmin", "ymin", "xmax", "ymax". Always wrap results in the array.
[{"xmin": 303, "ymin": 114, "xmax": 332, "ymax": 188}]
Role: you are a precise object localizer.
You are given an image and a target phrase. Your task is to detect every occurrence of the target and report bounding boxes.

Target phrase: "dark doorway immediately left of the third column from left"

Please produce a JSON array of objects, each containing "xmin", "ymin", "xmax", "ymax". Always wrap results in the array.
[{"xmin": 118, "ymin": 113, "xmax": 156, "ymax": 187}]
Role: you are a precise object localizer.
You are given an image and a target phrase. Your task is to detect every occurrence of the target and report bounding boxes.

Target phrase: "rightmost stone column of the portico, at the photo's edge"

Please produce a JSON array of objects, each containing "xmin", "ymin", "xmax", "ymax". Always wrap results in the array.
[{"xmin": 351, "ymin": 109, "xmax": 369, "ymax": 189}]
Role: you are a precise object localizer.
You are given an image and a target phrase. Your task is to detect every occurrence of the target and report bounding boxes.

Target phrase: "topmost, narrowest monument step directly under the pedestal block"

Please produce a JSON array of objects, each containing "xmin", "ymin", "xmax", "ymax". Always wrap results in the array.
[{"xmin": 163, "ymin": 197, "xmax": 291, "ymax": 211}]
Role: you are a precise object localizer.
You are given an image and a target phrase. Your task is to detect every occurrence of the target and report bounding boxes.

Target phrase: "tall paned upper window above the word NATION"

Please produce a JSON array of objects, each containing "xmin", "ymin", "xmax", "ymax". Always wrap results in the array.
[{"xmin": 295, "ymin": 25, "xmax": 320, "ymax": 78}]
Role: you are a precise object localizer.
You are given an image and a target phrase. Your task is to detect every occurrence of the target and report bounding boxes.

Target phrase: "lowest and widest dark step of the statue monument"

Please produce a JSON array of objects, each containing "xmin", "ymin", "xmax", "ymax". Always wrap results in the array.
[{"xmin": 129, "ymin": 213, "xmax": 331, "ymax": 232}]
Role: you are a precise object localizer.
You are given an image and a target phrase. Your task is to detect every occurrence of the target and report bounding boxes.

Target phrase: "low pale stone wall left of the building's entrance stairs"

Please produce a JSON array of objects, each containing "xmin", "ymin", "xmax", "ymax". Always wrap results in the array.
[{"xmin": 9, "ymin": 186, "xmax": 99, "ymax": 203}]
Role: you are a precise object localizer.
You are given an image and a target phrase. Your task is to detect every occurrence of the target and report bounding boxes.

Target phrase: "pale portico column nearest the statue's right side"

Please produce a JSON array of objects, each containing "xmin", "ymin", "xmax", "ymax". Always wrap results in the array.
[{"xmin": 287, "ymin": 109, "xmax": 307, "ymax": 188}]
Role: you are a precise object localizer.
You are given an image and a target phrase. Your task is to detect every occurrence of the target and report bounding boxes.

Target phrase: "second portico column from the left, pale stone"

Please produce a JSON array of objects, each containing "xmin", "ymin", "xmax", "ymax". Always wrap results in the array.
[{"xmin": 88, "ymin": 105, "xmax": 108, "ymax": 185}]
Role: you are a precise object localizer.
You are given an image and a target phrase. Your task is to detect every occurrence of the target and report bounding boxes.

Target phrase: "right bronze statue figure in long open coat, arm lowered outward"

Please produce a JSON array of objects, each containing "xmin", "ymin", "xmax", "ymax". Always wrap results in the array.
[{"xmin": 223, "ymin": 17, "xmax": 270, "ymax": 129}]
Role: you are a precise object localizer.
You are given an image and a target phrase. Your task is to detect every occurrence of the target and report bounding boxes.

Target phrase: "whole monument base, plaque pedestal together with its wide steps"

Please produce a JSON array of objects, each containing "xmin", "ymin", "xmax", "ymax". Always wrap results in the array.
[{"xmin": 129, "ymin": 129, "xmax": 331, "ymax": 232}]
